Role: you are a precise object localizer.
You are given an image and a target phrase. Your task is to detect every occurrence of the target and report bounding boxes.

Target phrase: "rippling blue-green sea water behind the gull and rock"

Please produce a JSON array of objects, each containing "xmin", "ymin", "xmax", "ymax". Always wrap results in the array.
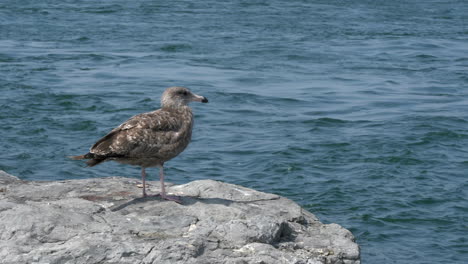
[{"xmin": 0, "ymin": 0, "xmax": 468, "ymax": 263}]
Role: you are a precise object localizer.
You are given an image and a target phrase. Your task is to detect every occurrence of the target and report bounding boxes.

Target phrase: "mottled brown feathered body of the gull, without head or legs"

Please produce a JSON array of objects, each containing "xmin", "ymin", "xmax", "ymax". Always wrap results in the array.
[{"xmin": 90, "ymin": 106, "xmax": 193, "ymax": 166}]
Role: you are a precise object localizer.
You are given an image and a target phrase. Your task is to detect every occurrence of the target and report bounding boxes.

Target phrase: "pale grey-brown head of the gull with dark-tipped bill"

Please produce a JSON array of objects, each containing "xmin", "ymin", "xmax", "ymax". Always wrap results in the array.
[{"xmin": 161, "ymin": 86, "xmax": 208, "ymax": 108}]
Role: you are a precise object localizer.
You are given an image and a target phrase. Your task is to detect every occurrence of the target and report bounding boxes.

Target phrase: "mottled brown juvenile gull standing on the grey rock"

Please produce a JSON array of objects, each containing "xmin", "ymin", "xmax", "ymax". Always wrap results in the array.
[{"xmin": 70, "ymin": 87, "xmax": 208, "ymax": 202}]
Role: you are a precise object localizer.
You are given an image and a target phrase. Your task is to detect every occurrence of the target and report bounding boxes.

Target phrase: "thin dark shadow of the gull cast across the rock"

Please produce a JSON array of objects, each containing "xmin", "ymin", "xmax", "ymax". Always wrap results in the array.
[{"xmin": 110, "ymin": 195, "xmax": 280, "ymax": 212}]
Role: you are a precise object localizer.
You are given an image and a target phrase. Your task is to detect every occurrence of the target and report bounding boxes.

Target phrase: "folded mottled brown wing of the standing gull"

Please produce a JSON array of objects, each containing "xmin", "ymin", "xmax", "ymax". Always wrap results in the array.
[{"xmin": 90, "ymin": 110, "xmax": 182, "ymax": 157}]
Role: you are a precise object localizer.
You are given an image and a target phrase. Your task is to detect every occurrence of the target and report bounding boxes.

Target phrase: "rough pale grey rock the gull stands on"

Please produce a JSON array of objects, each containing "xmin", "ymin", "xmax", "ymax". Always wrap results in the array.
[{"xmin": 0, "ymin": 171, "xmax": 360, "ymax": 264}]
